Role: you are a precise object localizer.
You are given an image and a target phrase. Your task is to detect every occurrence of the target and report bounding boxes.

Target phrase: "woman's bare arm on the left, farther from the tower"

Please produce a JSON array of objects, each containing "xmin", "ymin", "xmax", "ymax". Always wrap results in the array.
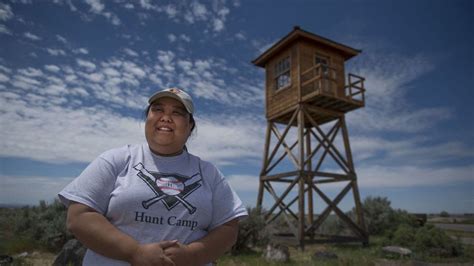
[{"xmin": 67, "ymin": 202, "xmax": 176, "ymax": 265}]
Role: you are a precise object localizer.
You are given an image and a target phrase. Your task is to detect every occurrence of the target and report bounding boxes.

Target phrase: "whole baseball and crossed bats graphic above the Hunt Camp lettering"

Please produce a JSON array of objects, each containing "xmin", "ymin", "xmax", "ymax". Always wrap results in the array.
[{"xmin": 133, "ymin": 163, "xmax": 202, "ymax": 214}]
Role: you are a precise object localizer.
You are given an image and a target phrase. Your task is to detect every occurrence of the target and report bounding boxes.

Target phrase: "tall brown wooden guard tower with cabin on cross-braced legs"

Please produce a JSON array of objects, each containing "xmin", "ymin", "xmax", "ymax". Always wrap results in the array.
[{"xmin": 252, "ymin": 27, "xmax": 368, "ymax": 249}]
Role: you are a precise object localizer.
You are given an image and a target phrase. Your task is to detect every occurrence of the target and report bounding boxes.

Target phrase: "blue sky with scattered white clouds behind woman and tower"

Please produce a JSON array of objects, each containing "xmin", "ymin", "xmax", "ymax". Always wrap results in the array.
[{"xmin": 0, "ymin": 0, "xmax": 474, "ymax": 213}]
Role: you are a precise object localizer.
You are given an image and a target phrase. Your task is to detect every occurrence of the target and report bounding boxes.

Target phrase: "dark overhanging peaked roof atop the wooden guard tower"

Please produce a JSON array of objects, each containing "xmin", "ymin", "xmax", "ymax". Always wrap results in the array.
[{"xmin": 252, "ymin": 26, "xmax": 362, "ymax": 67}]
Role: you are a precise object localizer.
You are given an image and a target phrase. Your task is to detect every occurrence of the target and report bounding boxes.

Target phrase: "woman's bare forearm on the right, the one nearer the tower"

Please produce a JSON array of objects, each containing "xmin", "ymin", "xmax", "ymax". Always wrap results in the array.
[{"xmin": 165, "ymin": 218, "xmax": 239, "ymax": 266}]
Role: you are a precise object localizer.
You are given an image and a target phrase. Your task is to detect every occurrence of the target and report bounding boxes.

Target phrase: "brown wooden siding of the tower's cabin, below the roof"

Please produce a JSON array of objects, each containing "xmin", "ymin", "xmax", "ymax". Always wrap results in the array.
[{"xmin": 265, "ymin": 34, "xmax": 364, "ymax": 123}]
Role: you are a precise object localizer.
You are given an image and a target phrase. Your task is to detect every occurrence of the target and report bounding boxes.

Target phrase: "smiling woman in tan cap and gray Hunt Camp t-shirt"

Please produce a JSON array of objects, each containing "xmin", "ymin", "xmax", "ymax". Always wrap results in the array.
[{"xmin": 59, "ymin": 88, "xmax": 247, "ymax": 265}]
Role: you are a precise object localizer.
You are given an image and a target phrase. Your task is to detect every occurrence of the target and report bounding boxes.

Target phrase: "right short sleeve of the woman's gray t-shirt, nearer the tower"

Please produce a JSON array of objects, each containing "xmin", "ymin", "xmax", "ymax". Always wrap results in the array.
[{"xmin": 209, "ymin": 167, "xmax": 248, "ymax": 230}]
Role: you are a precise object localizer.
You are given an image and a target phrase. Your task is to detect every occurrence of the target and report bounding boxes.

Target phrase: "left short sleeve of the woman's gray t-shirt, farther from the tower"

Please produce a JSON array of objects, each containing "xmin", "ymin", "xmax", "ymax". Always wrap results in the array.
[{"xmin": 58, "ymin": 157, "xmax": 117, "ymax": 214}]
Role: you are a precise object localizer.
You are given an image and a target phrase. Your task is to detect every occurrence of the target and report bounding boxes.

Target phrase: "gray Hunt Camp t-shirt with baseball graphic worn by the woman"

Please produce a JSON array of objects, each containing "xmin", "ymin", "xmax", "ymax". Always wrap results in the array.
[{"xmin": 59, "ymin": 143, "xmax": 247, "ymax": 265}]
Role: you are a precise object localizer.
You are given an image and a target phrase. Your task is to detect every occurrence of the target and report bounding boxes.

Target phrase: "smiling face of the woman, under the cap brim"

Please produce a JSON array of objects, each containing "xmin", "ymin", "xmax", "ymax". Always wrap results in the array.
[{"xmin": 145, "ymin": 97, "xmax": 192, "ymax": 154}]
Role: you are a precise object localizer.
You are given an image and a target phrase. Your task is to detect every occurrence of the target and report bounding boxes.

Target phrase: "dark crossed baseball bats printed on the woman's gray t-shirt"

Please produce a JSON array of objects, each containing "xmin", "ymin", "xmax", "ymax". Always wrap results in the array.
[{"xmin": 133, "ymin": 163, "xmax": 201, "ymax": 214}]
